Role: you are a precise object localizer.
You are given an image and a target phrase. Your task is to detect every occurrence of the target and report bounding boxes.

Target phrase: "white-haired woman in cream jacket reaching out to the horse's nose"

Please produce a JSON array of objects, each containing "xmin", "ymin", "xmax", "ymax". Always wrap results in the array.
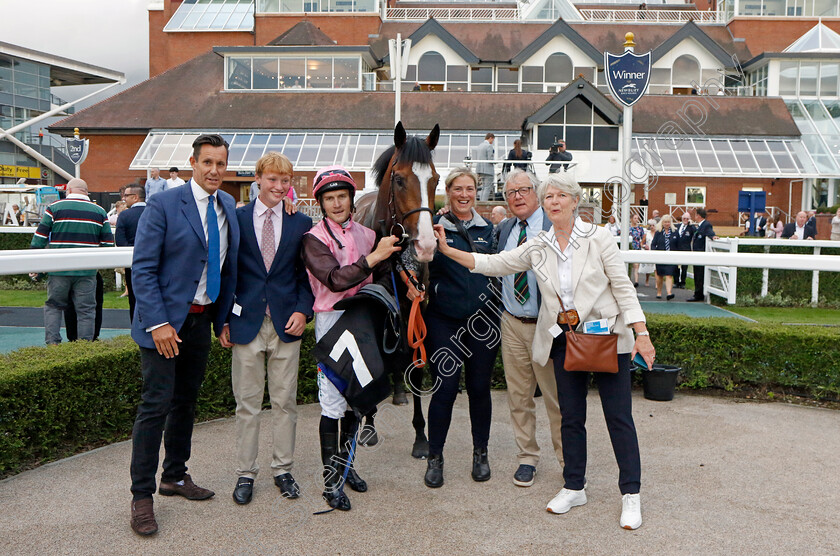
[{"xmin": 435, "ymin": 174, "xmax": 655, "ymax": 529}]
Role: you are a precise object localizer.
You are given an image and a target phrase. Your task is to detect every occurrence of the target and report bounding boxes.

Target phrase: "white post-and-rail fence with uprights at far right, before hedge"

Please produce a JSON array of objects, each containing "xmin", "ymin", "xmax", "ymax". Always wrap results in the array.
[{"xmin": 705, "ymin": 237, "xmax": 840, "ymax": 305}]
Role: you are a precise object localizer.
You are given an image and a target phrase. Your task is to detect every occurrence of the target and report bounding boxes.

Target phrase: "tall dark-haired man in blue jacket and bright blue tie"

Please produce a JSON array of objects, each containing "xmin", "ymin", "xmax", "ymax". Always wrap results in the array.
[{"xmin": 131, "ymin": 135, "xmax": 239, "ymax": 535}]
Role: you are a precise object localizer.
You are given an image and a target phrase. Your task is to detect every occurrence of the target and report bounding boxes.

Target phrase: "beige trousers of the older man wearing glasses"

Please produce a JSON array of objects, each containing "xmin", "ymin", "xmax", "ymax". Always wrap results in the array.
[{"xmin": 502, "ymin": 311, "xmax": 563, "ymax": 467}]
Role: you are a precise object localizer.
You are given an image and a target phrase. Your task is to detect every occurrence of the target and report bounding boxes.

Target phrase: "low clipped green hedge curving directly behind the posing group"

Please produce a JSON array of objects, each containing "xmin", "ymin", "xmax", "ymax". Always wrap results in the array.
[{"xmin": 0, "ymin": 315, "xmax": 840, "ymax": 477}]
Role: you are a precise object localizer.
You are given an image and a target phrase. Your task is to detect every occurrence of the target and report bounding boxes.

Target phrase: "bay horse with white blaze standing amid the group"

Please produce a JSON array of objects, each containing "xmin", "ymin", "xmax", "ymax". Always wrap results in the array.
[{"xmin": 356, "ymin": 122, "xmax": 440, "ymax": 459}]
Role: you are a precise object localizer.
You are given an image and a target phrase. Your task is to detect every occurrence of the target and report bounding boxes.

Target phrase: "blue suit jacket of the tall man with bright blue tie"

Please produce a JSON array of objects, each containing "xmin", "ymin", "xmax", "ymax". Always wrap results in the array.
[{"xmin": 131, "ymin": 180, "xmax": 239, "ymax": 349}]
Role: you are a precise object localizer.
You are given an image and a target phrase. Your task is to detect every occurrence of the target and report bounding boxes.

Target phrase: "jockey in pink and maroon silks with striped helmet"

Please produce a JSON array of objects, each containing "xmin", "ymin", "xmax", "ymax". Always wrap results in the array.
[{"xmin": 301, "ymin": 166, "xmax": 400, "ymax": 511}]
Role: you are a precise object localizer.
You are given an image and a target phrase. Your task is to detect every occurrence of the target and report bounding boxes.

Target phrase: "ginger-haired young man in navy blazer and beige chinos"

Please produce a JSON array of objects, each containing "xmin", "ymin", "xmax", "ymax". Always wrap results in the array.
[{"xmin": 220, "ymin": 152, "xmax": 315, "ymax": 504}]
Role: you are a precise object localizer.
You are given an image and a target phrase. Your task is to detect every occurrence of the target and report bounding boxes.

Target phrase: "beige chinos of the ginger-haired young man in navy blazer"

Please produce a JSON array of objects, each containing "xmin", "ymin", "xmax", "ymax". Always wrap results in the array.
[{"xmin": 231, "ymin": 317, "xmax": 300, "ymax": 479}]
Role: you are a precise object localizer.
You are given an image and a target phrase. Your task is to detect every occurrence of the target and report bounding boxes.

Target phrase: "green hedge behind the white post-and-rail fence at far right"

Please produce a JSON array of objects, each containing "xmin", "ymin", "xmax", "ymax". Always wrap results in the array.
[{"xmin": 738, "ymin": 245, "xmax": 840, "ymax": 303}]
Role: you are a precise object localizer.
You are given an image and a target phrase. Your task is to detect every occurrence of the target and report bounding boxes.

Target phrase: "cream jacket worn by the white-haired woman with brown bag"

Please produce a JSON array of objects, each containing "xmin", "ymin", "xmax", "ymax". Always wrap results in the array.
[{"xmin": 472, "ymin": 219, "xmax": 645, "ymax": 365}]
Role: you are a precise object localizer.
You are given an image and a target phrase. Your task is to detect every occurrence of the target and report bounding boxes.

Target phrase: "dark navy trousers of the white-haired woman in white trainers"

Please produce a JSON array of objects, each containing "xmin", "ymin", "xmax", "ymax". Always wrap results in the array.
[{"xmin": 551, "ymin": 334, "xmax": 642, "ymax": 495}]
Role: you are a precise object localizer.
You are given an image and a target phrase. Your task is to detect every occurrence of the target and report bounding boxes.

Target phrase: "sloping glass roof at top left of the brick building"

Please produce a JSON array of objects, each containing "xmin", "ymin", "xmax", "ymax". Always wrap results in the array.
[{"xmin": 163, "ymin": 0, "xmax": 254, "ymax": 31}]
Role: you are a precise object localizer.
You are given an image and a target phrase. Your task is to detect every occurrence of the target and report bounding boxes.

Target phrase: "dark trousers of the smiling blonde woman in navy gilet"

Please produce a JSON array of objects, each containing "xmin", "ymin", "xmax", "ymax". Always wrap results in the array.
[{"xmin": 426, "ymin": 308, "xmax": 501, "ymax": 455}]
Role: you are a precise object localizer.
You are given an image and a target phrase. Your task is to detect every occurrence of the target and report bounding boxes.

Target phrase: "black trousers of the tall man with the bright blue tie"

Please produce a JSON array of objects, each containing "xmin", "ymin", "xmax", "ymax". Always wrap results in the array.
[{"xmin": 131, "ymin": 312, "xmax": 211, "ymax": 500}]
